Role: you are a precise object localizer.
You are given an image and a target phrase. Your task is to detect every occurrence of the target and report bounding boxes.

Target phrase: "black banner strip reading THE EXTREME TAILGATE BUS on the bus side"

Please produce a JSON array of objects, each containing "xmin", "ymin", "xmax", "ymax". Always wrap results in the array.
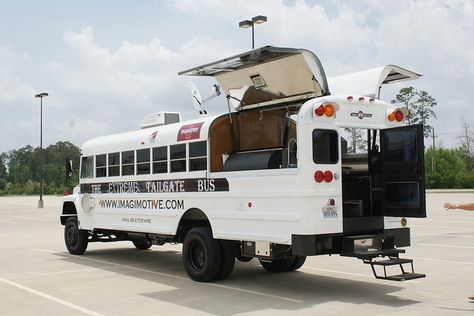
[{"xmin": 81, "ymin": 178, "xmax": 229, "ymax": 194}]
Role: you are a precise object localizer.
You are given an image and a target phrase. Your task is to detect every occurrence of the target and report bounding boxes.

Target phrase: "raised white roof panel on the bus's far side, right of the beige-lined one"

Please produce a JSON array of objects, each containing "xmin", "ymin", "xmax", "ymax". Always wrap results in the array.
[{"xmin": 328, "ymin": 65, "xmax": 422, "ymax": 98}]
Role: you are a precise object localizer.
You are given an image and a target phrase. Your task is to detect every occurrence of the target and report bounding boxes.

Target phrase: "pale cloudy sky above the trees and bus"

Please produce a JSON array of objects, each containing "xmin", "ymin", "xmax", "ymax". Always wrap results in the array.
[{"xmin": 0, "ymin": 0, "xmax": 474, "ymax": 152}]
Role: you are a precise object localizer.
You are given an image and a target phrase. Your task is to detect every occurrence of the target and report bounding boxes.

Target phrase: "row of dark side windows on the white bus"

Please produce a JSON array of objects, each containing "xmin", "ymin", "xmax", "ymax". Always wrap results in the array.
[{"xmin": 81, "ymin": 141, "xmax": 207, "ymax": 178}]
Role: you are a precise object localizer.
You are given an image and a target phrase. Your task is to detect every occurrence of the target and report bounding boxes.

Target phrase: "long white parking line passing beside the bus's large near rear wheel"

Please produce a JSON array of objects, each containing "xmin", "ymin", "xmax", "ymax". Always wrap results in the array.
[{"xmin": 31, "ymin": 249, "xmax": 303, "ymax": 303}]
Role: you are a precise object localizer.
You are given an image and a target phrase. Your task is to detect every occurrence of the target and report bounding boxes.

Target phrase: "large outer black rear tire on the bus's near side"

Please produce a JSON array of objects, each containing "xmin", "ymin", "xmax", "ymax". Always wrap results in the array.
[{"xmin": 182, "ymin": 227, "xmax": 222, "ymax": 282}]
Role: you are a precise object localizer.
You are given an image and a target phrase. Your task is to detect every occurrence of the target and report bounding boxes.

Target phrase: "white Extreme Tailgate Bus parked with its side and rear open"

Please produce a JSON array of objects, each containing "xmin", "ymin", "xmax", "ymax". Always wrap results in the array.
[{"xmin": 61, "ymin": 46, "xmax": 426, "ymax": 281}]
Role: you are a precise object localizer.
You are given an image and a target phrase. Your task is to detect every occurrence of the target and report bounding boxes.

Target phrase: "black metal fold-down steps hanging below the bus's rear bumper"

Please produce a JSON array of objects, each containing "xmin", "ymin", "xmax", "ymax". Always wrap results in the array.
[{"xmin": 363, "ymin": 255, "xmax": 426, "ymax": 281}]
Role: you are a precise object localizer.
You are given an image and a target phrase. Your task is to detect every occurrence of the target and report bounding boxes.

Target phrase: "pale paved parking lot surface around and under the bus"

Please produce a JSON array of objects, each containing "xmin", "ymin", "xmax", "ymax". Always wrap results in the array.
[{"xmin": 0, "ymin": 192, "xmax": 474, "ymax": 316}]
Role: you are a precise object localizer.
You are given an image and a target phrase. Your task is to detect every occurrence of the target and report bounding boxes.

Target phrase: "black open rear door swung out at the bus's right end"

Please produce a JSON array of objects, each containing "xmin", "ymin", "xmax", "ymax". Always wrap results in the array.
[{"xmin": 380, "ymin": 125, "xmax": 426, "ymax": 217}]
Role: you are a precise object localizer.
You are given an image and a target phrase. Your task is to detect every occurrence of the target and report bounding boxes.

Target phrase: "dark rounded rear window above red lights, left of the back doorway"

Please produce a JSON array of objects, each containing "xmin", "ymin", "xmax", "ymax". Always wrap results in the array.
[{"xmin": 313, "ymin": 129, "xmax": 339, "ymax": 164}]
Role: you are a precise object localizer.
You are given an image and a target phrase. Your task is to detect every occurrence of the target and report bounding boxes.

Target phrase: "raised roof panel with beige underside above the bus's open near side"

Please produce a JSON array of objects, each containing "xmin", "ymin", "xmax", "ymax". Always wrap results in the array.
[{"xmin": 179, "ymin": 46, "xmax": 329, "ymax": 109}]
